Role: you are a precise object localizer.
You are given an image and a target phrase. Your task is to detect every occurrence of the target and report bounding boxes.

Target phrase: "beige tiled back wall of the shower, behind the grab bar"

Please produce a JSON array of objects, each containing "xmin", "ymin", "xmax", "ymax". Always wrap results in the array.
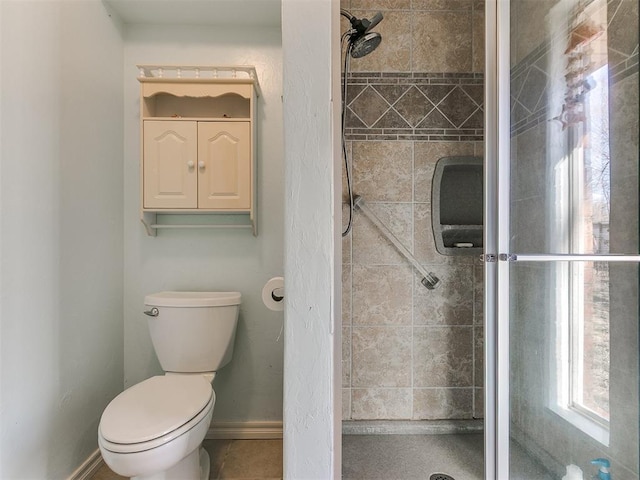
[{"xmin": 342, "ymin": 0, "xmax": 484, "ymax": 420}]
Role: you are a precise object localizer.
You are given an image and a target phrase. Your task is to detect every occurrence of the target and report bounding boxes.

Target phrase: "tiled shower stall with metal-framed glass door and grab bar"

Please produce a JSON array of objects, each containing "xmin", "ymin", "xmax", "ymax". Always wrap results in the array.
[{"xmin": 336, "ymin": 0, "xmax": 640, "ymax": 480}]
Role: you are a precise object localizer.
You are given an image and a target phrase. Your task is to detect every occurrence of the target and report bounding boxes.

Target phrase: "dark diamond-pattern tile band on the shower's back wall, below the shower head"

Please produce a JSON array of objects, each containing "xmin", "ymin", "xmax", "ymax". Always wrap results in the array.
[{"xmin": 345, "ymin": 72, "xmax": 484, "ymax": 141}]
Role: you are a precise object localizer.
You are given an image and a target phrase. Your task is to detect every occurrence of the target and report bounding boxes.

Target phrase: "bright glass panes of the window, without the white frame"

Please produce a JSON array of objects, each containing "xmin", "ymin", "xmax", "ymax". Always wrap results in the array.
[{"xmin": 569, "ymin": 65, "xmax": 610, "ymax": 425}]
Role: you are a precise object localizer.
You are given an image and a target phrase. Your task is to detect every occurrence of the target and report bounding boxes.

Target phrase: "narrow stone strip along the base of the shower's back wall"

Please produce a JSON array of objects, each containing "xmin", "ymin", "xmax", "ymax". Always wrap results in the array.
[{"xmin": 342, "ymin": 420, "xmax": 484, "ymax": 435}]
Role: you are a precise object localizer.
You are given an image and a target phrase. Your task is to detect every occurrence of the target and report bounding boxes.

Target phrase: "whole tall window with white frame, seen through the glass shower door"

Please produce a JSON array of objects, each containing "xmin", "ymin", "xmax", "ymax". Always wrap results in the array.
[{"xmin": 548, "ymin": 0, "xmax": 610, "ymax": 445}]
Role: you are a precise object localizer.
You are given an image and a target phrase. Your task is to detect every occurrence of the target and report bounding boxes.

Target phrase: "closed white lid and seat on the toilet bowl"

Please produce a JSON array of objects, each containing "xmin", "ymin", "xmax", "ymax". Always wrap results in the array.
[{"xmin": 99, "ymin": 375, "xmax": 215, "ymax": 453}]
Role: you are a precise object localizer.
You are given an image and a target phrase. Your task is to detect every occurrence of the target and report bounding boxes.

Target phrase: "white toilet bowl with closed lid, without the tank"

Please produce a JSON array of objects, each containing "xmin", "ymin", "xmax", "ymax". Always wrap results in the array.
[{"xmin": 98, "ymin": 375, "xmax": 215, "ymax": 480}]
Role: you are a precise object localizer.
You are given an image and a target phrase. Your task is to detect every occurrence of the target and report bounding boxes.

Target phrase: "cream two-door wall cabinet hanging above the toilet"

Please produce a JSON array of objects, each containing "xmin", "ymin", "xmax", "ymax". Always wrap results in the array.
[{"xmin": 139, "ymin": 66, "xmax": 259, "ymax": 235}]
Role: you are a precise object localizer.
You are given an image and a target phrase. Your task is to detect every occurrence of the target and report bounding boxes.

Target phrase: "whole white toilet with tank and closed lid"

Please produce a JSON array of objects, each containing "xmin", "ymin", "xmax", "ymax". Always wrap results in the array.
[{"xmin": 98, "ymin": 292, "xmax": 240, "ymax": 480}]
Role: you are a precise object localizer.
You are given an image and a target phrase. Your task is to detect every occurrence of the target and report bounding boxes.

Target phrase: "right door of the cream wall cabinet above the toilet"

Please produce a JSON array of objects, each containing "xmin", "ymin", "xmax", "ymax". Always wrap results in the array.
[{"xmin": 198, "ymin": 122, "xmax": 252, "ymax": 210}]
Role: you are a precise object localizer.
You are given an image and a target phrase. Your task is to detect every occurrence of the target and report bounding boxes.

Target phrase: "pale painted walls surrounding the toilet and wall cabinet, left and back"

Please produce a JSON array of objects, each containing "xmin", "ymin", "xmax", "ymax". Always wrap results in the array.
[{"xmin": 0, "ymin": 0, "xmax": 284, "ymax": 478}]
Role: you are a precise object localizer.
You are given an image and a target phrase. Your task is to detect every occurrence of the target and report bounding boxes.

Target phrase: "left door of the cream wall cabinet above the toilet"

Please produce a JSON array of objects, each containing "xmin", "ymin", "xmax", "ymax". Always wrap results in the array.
[{"xmin": 142, "ymin": 121, "xmax": 198, "ymax": 209}]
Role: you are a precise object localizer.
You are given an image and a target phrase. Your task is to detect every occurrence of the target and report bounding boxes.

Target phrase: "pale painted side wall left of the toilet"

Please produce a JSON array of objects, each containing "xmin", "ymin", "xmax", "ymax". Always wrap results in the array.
[{"xmin": 0, "ymin": 0, "xmax": 123, "ymax": 479}]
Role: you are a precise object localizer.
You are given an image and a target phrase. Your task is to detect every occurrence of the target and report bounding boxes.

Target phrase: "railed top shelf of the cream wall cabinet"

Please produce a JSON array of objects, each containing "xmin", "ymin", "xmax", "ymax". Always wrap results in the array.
[{"xmin": 136, "ymin": 65, "xmax": 261, "ymax": 96}]
